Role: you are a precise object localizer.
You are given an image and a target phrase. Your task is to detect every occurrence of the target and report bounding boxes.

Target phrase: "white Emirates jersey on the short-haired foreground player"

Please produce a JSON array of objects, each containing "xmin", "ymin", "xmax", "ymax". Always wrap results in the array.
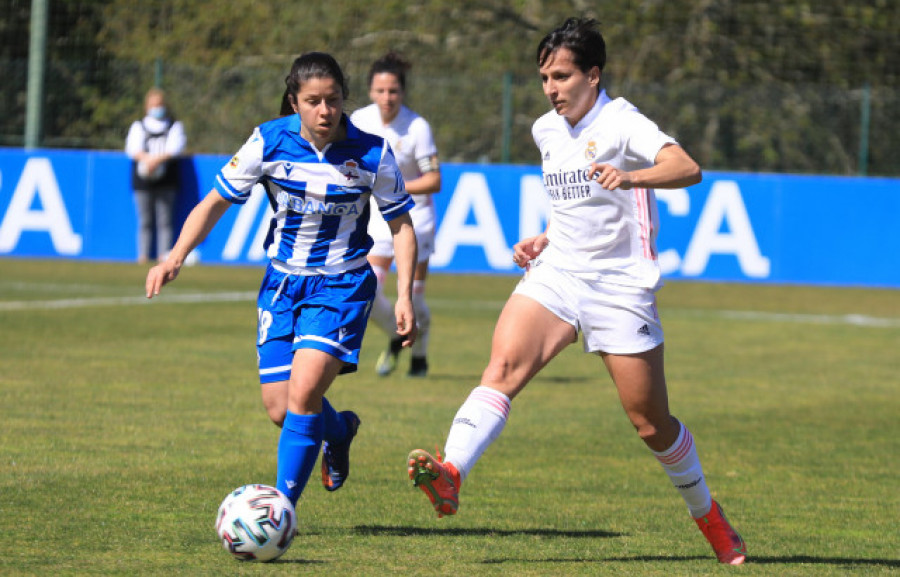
[{"xmin": 532, "ymin": 91, "xmax": 676, "ymax": 288}]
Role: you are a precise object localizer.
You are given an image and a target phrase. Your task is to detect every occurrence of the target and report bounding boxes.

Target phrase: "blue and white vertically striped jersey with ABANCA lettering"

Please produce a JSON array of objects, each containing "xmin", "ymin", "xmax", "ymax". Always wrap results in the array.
[{"xmin": 215, "ymin": 114, "xmax": 413, "ymax": 274}]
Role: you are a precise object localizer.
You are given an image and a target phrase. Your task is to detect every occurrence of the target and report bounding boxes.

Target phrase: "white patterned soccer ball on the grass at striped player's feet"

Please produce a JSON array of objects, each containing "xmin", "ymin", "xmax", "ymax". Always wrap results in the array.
[{"xmin": 216, "ymin": 484, "xmax": 297, "ymax": 561}]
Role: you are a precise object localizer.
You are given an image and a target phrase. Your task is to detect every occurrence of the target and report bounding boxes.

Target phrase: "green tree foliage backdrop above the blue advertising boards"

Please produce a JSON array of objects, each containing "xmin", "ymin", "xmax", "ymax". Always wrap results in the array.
[{"xmin": 0, "ymin": 0, "xmax": 900, "ymax": 174}]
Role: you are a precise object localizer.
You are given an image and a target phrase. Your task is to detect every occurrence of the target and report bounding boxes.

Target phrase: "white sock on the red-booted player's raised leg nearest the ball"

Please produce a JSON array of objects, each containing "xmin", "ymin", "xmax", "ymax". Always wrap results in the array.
[{"xmin": 444, "ymin": 386, "xmax": 509, "ymax": 481}]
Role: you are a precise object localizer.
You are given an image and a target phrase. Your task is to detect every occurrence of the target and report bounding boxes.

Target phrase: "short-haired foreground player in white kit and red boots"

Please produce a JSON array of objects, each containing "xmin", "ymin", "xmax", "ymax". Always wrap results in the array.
[{"xmin": 408, "ymin": 18, "xmax": 746, "ymax": 565}]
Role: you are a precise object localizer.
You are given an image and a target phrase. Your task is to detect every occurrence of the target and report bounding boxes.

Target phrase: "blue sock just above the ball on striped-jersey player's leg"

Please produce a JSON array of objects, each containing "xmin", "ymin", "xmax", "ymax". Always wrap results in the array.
[{"xmin": 276, "ymin": 405, "xmax": 328, "ymax": 505}]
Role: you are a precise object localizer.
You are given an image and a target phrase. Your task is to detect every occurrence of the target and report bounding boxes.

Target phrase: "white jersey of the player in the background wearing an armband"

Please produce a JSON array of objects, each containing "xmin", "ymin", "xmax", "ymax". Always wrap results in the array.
[{"xmin": 350, "ymin": 104, "xmax": 437, "ymax": 233}]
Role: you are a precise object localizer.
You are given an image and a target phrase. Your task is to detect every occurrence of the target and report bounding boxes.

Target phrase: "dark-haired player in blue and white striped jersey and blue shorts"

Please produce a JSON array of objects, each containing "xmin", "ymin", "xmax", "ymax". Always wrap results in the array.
[{"xmin": 146, "ymin": 52, "xmax": 416, "ymax": 504}]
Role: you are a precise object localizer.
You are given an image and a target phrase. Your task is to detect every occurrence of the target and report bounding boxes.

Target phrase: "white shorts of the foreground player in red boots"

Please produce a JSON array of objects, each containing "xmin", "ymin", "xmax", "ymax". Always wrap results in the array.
[{"xmin": 513, "ymin": 262, "xmax": 663, "ymax": 355}]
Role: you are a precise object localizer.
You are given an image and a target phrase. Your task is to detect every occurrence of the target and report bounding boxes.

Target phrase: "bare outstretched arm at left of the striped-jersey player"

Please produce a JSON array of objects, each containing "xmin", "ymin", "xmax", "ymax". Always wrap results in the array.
[{"xmin": 144, "ymin": 190, "xmax": 231, "ymax": 299}]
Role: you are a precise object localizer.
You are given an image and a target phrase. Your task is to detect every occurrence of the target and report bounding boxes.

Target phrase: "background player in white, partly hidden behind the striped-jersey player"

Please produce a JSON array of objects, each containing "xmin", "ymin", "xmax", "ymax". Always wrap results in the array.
[{"xmin": 350, "ymin": 52, "xmax": 441, "ymax": 377}]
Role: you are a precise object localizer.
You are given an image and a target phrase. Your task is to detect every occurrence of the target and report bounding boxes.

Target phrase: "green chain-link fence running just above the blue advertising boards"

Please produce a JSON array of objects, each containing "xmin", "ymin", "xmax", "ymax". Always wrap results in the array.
[{"xmin": 0, "ymin": 59, "xmax": 900, "ymax": 176}]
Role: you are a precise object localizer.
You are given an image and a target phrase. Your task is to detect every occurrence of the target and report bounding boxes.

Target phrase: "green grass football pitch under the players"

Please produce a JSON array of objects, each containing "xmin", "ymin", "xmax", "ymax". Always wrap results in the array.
[{"xmin": 0, "ymin": 259, "xmax": 900, "ymax": 577}]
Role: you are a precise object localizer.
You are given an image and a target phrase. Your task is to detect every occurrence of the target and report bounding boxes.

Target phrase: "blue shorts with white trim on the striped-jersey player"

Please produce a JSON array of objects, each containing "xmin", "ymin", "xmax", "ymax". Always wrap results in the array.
[{"xmin": 256, "ymin": 264, "xmax": 376, "ymax": 383}]
